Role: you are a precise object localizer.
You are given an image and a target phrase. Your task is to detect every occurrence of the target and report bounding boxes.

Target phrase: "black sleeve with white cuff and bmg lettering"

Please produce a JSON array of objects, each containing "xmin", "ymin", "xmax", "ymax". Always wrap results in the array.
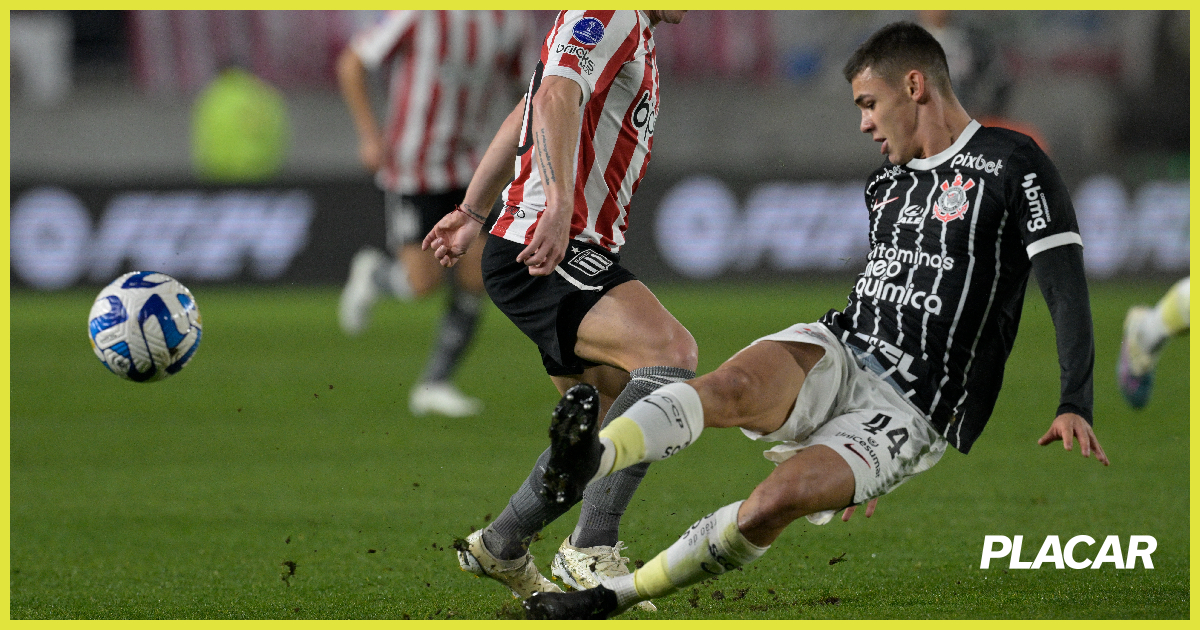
[{"xmin": 1006, "ymin": 140, "xmax": 1084, "ymax": 259}]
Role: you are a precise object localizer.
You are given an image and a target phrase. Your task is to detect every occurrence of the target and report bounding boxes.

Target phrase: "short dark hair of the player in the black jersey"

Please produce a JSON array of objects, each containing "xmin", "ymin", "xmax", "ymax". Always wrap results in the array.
[{"xmin": 841, "ymin": 22, "xmax": 952, "ymax": 95}]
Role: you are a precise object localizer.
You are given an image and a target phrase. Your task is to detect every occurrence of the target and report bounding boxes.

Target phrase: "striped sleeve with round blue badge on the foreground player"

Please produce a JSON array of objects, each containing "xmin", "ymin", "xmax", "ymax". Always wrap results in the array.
[{"xmin": 542, "ymin": 11, "xmax": 641, "ymax": 103}]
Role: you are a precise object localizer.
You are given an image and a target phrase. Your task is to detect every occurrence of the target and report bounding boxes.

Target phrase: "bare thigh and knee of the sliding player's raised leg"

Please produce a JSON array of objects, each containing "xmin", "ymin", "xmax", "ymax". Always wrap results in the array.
[{"xmin": 691, "ymin": 341, "xmax": 824, "ymax": 434}]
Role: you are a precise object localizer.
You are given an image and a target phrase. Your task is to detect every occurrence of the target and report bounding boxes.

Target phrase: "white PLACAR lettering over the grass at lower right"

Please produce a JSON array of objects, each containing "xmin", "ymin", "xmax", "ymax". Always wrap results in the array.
[{"xmin": 979, "ymin": 534, "xmax": 1158, "ymax": 569}]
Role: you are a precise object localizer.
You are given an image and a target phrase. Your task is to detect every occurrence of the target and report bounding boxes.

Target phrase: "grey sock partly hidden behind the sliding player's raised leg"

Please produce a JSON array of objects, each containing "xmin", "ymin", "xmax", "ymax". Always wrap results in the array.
[{"xmin": 571, "ymin": 366, "xmax": 696, "ymax": 547}]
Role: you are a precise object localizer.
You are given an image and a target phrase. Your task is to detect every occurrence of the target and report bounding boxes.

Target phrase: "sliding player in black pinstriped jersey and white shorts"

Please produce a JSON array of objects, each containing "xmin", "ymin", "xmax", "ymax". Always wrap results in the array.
[{"xmin": 526, "ymin": 23, "xmax": 1109, "ymax": 618}]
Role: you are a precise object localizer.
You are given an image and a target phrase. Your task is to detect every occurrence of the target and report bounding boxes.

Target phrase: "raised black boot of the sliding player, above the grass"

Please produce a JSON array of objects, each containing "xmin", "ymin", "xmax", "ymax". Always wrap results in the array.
[{"xmin": 542, "ymin": 383, "xmax": 604, "ymax": 505}]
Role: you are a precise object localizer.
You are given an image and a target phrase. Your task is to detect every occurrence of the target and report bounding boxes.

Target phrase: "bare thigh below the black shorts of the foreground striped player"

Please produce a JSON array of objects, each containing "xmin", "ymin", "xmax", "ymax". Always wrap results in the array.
[{"xmin": 575, "ymin": 280, "xmax": 697, "ymax": 372}]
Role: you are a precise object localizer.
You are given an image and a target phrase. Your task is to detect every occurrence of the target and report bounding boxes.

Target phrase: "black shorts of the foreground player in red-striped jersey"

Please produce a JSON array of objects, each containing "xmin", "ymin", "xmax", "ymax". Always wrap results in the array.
[{"xmin": 482, "ymin": 234, "xmax": 637, "ymax": 377}]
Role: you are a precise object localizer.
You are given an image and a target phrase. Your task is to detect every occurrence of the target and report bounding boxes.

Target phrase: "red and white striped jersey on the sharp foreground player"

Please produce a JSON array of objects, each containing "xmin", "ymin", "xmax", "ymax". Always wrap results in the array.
[{"xmin": 492, "ymin": 11, "xmax": 659, "ymax": 252}]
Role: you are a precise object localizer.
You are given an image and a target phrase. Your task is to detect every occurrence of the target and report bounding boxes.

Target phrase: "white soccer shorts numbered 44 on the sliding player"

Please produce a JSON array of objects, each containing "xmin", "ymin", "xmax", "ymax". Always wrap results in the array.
[{"xmin": 742, "ymin": 323, "xmax": 947, "ymax": 524}]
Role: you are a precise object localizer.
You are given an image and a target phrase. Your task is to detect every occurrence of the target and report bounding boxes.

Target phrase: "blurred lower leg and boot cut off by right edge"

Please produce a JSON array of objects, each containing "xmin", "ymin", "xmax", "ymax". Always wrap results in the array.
[{"xmin": 1117, "ymin": 276, "xmax": 1192, "ymax": 409}]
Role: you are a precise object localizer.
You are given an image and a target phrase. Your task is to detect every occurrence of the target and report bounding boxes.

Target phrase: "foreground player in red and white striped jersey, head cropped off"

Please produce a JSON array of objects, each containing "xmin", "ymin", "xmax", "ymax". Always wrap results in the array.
[{"xmin": 424, "ymin": 11, "xmax": 697, "ymax": 610}]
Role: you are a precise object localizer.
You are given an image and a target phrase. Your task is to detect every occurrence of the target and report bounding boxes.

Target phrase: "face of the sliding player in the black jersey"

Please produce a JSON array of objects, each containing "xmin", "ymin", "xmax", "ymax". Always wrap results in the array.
[{"xmin": 850, "ymin": 67, "xmax": 924, "ymax": 164}]
